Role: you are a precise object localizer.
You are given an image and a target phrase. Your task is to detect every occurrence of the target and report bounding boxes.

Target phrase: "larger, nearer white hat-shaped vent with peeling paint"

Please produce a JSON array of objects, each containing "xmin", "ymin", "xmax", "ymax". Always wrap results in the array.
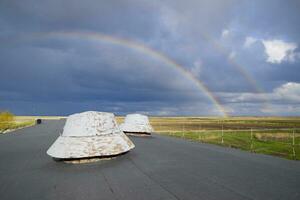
[{"xmin": 47, "ymin": 111, "xmax": 134, "ymax": 159}]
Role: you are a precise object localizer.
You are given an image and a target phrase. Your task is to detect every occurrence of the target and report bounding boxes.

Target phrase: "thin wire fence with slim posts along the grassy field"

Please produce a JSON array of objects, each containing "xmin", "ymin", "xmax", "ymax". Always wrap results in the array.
[{"xmin": 154, "ymin": 123, "xmax": 300, "ymax": 160}]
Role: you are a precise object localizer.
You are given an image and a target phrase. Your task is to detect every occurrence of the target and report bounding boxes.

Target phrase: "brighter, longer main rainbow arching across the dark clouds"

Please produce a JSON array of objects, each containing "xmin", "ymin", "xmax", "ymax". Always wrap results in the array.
[{"xmin": 36, "ymin": 32, "xmax": 228, "ymax": 117}]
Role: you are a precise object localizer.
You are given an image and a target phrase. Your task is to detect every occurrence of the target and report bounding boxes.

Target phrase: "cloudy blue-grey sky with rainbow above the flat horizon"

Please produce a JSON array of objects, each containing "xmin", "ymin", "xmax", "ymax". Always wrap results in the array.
[{"xmin": 0, "ymin": 0, "xmax": 300, "ymax": 116}]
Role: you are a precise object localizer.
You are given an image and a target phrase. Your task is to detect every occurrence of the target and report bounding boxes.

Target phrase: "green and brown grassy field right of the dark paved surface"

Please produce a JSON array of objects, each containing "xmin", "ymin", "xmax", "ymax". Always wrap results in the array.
[{"xmin": 118, "ymin": 117, "xmax": 300, "ymax": 160}]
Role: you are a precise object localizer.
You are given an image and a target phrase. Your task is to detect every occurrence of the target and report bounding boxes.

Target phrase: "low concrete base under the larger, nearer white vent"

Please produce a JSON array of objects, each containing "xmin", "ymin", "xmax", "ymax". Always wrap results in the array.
[{"xmin": 53, "ymin": 152, "xmax": 128, "ymax": 164}]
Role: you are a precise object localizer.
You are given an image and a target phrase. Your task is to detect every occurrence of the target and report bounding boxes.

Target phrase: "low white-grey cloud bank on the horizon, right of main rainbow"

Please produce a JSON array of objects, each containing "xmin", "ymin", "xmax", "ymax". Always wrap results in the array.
[{"xmin": 217, "ymin": 82, "xmax": 300, "ymax": 115}]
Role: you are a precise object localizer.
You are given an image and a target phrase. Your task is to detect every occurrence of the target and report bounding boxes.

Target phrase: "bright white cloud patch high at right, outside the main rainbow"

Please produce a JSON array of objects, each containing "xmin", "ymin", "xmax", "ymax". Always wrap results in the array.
[{"xmin": 262, "ymin": 40, "xmax": 297, "ymax": 64}]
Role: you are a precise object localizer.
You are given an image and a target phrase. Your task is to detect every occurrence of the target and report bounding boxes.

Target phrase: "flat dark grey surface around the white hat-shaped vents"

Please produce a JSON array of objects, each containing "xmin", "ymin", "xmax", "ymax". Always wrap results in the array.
[{"xmin": 0, "ymin": 121, "xmax": 300, "ymax": 200}]
